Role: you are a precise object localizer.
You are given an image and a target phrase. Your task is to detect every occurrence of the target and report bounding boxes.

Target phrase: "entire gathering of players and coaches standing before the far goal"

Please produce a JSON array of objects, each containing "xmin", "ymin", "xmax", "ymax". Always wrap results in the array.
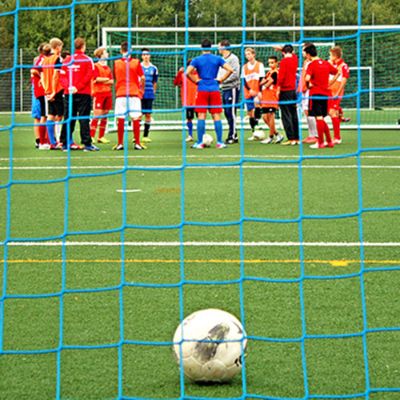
[{"xmin": 31, "ymin": 38, "xmax": 349, "ymax": 151}]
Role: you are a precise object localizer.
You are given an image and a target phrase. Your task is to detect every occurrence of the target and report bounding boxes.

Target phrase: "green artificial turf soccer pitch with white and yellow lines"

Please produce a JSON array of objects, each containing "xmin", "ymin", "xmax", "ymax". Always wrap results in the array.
[{"xmin": 0, "ymin": 116, "xmax": 400, "ymax": 400}]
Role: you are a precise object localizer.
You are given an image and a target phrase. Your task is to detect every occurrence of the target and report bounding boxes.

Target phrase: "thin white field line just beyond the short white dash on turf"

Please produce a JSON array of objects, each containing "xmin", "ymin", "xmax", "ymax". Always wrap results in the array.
[{"xmin": 0, "ymin": 164, "xmax": 400, "ymax": 171}]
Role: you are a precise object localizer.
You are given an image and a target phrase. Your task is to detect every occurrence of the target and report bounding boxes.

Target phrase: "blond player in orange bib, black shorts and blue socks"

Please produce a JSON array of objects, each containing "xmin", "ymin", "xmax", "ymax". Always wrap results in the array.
[{"xmin": 41, "ymin": 38, "xmax": 64, "ymax": 150}]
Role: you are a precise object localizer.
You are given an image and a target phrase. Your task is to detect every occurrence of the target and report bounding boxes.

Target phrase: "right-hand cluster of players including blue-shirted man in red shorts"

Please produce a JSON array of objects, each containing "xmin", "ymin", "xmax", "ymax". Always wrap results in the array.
[{"xmin": 183, "ymin": 39, "xmax": 349, "ymax": 149}]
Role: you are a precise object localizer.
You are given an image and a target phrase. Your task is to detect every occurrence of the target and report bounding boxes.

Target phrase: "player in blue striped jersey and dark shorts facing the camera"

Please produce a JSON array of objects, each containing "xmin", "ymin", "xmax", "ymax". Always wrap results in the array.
[{"xmin": 142, "ymin": 49, "xmax": 158, "ymax": 143}]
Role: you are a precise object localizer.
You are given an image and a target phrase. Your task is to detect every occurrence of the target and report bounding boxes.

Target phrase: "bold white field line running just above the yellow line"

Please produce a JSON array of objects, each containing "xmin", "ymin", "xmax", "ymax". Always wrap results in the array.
[{"xmin": 0, "ymin": 241, "xmax": 400, "ymax": 247}]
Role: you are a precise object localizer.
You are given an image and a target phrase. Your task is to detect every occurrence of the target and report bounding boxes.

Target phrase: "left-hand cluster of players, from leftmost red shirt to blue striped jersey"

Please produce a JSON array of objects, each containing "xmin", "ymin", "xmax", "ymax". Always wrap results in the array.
[{"xmin": 31, "ymin": 38, "xmax": 158, "ymax": 151}]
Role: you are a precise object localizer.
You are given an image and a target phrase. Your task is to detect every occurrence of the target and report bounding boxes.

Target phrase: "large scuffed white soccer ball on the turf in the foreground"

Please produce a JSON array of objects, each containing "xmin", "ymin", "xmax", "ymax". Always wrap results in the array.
[{"xmin": 173, "ymin": 308, "xmax": 247, "ymax": 382}]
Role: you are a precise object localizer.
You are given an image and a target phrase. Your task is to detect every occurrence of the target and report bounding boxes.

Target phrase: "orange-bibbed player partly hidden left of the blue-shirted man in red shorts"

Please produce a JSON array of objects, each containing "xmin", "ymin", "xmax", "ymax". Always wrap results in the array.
[{"xmin": 174, "ymin": 60, "xmax": 197, "ymax": 142}]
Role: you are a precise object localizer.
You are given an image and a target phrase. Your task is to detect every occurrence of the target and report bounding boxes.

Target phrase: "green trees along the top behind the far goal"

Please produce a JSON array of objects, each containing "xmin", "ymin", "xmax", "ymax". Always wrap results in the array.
[{"xmin": 0, "ymin": 0, "xmax": 400, "ymax": 49}]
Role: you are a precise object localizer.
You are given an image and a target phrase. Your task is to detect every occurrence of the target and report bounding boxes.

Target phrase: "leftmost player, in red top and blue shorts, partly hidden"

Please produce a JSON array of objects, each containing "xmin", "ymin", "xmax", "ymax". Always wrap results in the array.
[{"xmin": 30, "ymin": 43, "xmax": 50, "ymax": 150}]
